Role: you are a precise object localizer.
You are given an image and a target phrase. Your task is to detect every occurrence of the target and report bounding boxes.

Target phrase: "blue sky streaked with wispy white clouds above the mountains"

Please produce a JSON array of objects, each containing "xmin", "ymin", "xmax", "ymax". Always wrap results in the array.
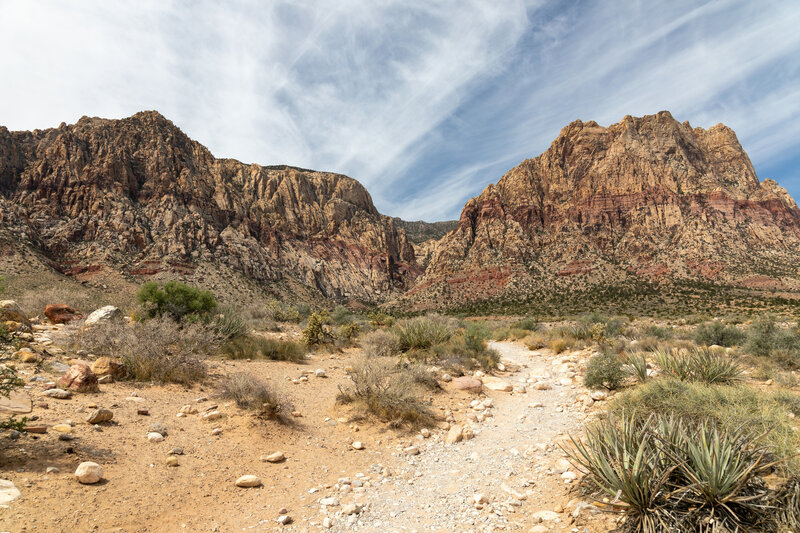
[{"xmin": 0, "ymin": 0, "xmax": 800, "ymax": 221}]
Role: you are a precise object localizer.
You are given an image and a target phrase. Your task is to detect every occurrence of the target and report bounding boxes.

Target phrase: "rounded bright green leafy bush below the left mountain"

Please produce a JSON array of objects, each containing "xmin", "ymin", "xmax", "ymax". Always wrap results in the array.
[{"xmin": 136, "ymin": 281, "xmax": 217, "ymax": 322}]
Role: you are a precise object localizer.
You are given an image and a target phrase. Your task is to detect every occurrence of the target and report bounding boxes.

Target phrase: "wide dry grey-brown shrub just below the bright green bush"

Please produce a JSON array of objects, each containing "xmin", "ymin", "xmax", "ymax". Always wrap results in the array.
[{"xmin": 65, "ymin": 318, "xmax": 219, "ymax": 384}]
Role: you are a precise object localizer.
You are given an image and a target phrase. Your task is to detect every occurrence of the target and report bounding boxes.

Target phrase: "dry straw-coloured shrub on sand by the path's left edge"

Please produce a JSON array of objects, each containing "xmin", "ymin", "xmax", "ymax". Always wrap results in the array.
[{"xmin": 337, "ymin": 358, "xmax": 433, "ymax": 426}]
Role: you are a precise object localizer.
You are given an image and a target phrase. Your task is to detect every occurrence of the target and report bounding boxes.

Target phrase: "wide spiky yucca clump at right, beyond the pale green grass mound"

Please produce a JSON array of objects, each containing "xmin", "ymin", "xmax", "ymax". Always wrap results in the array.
[{"xmin": 653, "ymin": 348, "xmax": 742, "ymax": 384}]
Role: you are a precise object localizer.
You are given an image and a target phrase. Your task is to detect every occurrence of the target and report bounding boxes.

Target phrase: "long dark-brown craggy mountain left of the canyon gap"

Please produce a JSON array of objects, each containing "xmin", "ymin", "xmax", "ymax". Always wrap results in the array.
[{"xmin": 0, "ymin": 112, "xmax": 420, "ymax": 302}]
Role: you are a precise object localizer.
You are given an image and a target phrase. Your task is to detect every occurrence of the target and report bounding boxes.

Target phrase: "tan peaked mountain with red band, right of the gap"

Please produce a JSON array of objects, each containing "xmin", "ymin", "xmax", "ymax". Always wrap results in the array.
[{"xmin": 403, "ymin": 111, "xmax": 800, "ymax": 307}]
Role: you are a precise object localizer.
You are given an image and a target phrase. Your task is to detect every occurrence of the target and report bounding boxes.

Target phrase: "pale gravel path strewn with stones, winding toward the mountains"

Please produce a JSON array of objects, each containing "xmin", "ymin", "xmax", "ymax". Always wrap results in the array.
[{"xmin": 331, "ymin": 342, "xmax": 587, "ymax": 532}]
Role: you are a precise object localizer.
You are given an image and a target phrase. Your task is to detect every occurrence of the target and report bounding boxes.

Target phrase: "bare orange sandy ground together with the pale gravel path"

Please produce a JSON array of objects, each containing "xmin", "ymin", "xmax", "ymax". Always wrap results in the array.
[{"xmin": 0, "ymin": 332, "xmax": 610, "ymax": 533}]
